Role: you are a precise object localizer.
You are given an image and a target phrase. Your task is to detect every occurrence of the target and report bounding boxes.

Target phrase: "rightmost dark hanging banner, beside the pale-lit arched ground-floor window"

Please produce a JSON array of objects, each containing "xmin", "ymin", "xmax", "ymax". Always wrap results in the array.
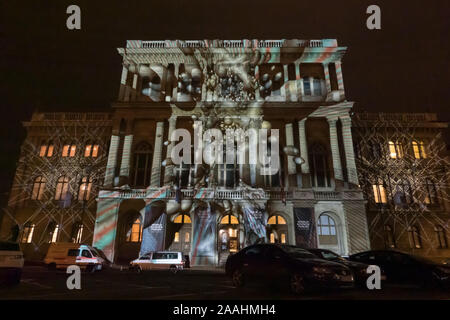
[{"xmin": 294, "ymin": 208, "xmax": 317, "ymax": 248}]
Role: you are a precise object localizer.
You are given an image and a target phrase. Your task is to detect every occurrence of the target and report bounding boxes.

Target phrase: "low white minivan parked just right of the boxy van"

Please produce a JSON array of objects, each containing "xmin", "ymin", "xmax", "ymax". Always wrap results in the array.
[{"xmin": 130, "ymin": 251, "xmax": 184, "ymax": 272}]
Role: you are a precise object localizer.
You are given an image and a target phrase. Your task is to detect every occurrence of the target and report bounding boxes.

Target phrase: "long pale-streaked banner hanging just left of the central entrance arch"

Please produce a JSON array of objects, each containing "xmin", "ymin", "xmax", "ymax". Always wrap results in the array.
[{"xmin": 191, "ymin": 203, "xmax": 216, "ymax": 265}]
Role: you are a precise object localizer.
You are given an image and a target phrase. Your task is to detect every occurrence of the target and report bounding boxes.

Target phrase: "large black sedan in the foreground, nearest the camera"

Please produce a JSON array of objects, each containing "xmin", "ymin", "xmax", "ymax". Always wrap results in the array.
[{"xmin": 225, "ymin": 244, "xmax": 354, "ymax": 294}]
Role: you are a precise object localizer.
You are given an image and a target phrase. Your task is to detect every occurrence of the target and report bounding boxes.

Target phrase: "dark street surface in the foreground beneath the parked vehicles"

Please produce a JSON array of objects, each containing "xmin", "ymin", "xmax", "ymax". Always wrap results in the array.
[{"xmin": 0, "ymin": 266, "xmax": 450, "ymax": 301}]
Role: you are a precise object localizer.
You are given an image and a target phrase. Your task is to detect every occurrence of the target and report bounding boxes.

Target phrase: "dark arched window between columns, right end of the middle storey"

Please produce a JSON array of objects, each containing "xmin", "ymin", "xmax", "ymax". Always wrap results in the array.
[{"xmin": 309, "ymin": 144, "xmax": 330, "ymax": 187}]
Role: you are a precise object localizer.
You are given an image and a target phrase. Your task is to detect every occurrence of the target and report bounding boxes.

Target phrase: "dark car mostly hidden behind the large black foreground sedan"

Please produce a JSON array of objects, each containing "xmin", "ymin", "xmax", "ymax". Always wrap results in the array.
[{"xmin": 307, "ymin": 248, "xmax": 386, "ymax": 287}]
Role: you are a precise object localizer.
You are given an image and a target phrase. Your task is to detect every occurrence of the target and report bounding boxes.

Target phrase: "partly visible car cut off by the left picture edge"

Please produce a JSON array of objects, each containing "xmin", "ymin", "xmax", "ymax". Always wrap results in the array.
[{"xmin": 0, "ymin": 242, "xmax": 24, "ymax": 284}]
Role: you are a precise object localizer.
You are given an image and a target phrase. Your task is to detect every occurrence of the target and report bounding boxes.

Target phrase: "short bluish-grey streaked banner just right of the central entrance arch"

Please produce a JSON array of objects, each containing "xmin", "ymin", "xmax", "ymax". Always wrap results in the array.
[{"xmin": 243, "ymin": 206, "xmax": 267, "ymax": 246}]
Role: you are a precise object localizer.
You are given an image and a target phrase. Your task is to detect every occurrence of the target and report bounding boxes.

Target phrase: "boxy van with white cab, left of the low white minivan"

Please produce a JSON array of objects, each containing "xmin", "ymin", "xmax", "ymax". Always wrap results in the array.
[{"xmin": 44, "ymin": 242, "xmax": 107, "ymax": 271}]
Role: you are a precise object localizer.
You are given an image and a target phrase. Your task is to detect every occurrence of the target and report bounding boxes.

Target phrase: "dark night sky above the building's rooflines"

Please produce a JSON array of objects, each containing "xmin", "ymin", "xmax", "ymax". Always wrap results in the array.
[{"xmin": 0, "ymin": 0, "xmax": 450, "ymax": 200}]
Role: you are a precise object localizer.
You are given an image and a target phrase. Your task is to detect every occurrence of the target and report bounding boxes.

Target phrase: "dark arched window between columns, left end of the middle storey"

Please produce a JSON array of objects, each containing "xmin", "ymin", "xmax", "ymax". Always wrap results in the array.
[{"xmin": 131, "ymin": 142, "xmax": 152, "ymax": 187}]
